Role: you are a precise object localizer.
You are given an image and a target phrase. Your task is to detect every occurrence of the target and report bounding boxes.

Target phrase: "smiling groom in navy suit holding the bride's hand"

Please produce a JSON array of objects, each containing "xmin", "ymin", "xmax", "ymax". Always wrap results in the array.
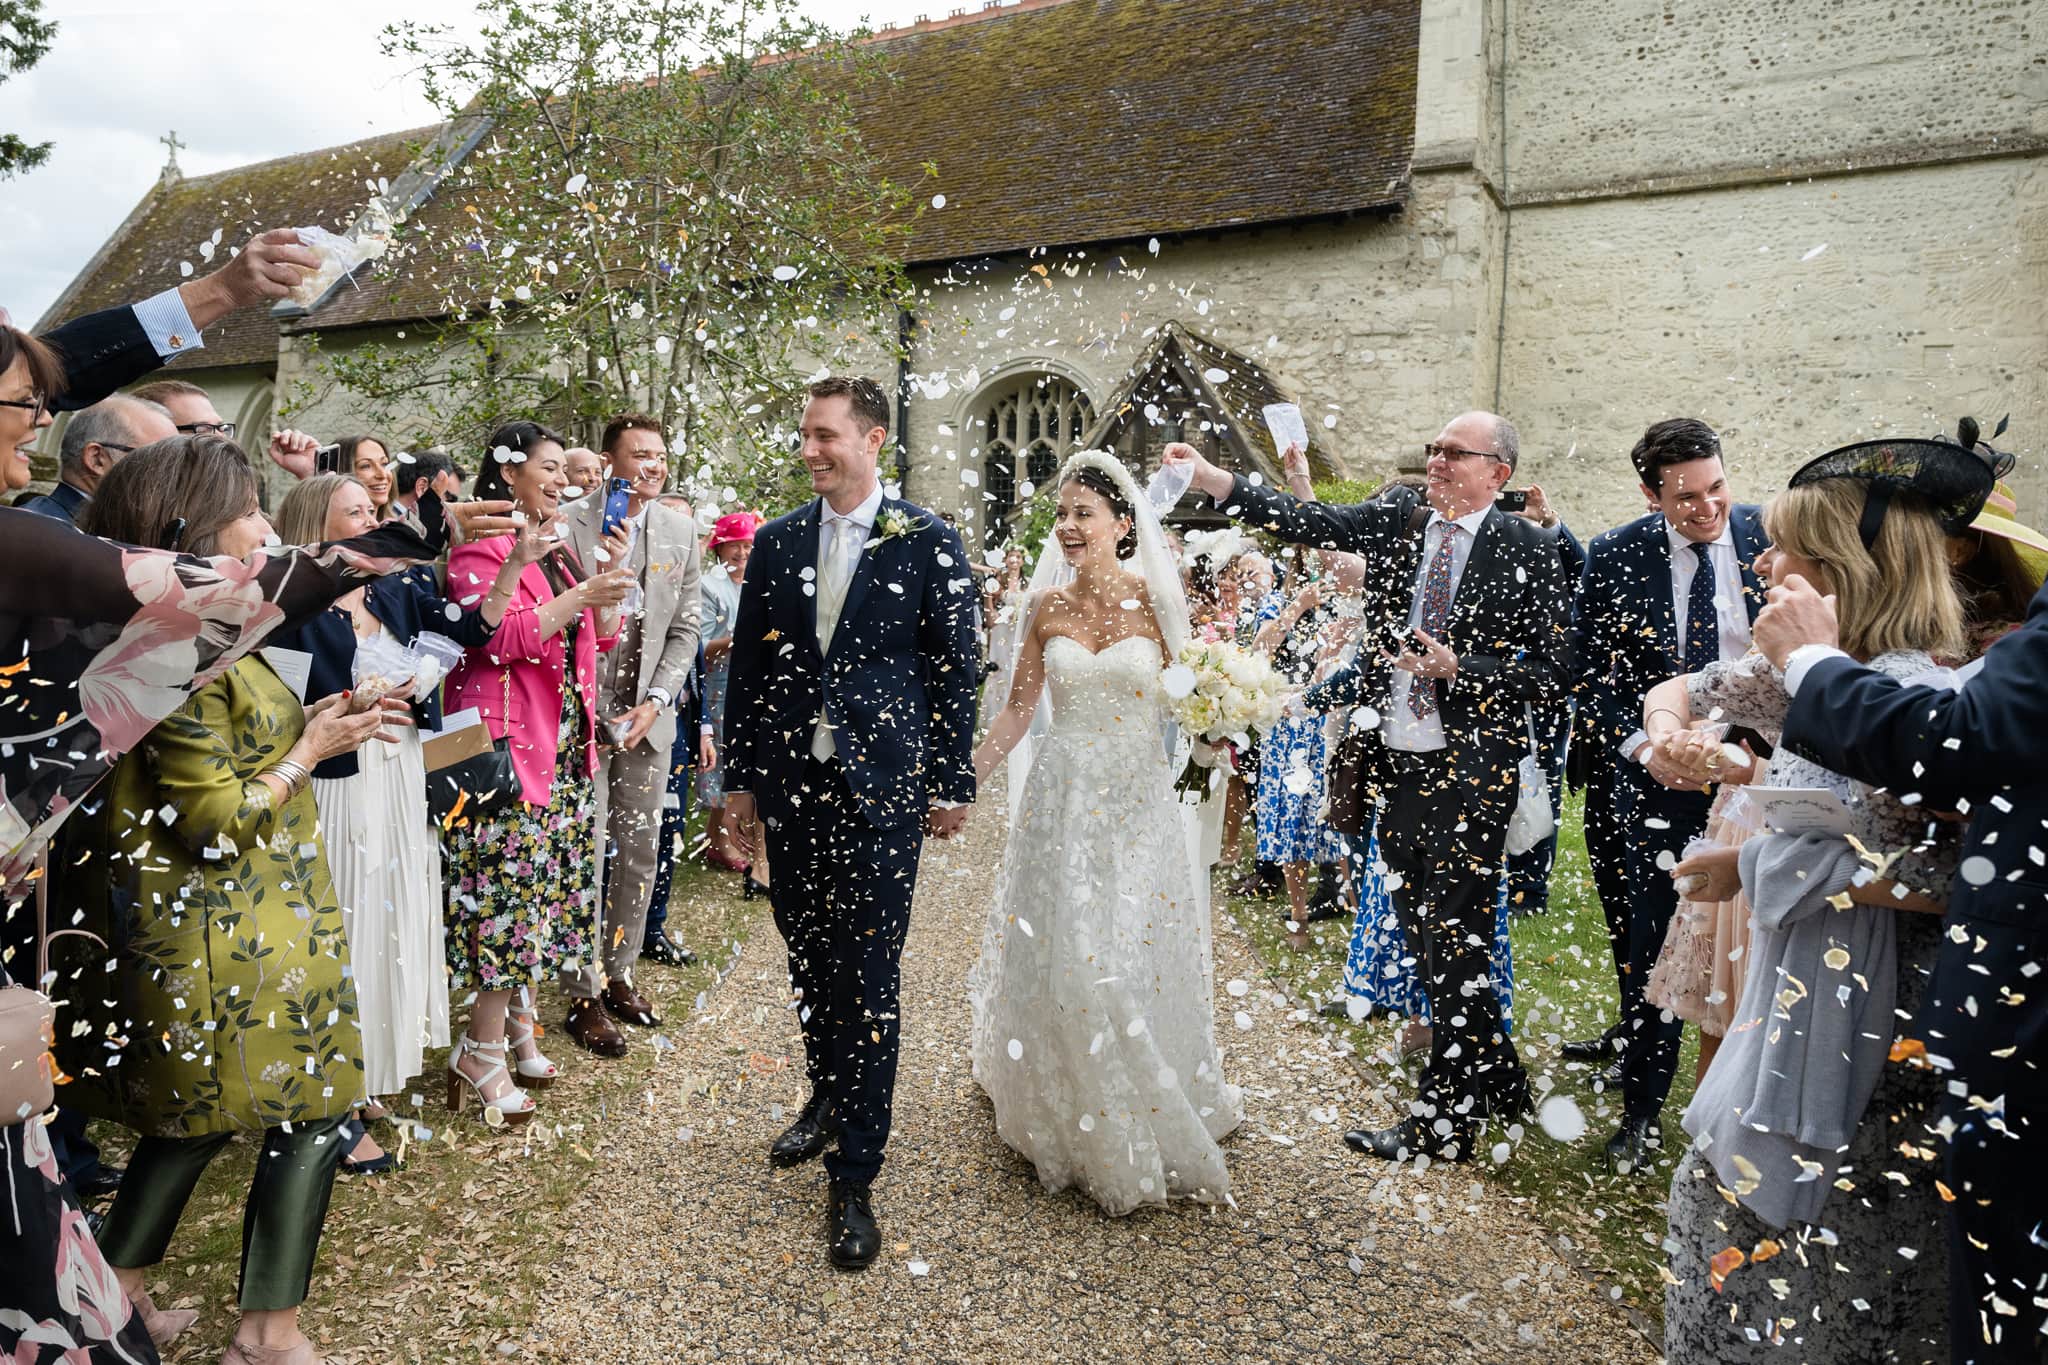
[{"xmin": 725, "ymin": 379, "xmax": 977, "ymax": 1271}]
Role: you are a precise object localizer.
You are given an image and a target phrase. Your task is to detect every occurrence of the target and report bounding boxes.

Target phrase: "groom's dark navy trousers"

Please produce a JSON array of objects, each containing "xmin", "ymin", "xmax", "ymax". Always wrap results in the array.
[{"xmin": 768, "ymin": 759, "xmax": 924, "ymax": 1185}]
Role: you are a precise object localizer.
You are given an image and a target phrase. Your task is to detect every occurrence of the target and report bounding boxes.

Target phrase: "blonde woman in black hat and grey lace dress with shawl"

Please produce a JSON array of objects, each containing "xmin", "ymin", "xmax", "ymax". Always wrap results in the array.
[{"xmin": 1645, "ymin": 442, "xmax": 1991, "ymax": 1365}]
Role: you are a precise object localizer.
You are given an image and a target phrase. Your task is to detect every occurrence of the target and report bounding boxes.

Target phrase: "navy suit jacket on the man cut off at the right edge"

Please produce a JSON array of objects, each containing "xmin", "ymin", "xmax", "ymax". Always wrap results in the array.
[{"xmin": 1784, "ymin": 587, "xmax": 2048, "ymax": 1109}]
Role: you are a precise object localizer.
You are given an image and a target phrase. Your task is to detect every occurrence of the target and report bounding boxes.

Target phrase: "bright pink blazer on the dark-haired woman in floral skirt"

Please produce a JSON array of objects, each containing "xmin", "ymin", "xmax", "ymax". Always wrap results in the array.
[{"xmin": 446, "ymin": 536, "xmax": 618, "ymax": 806}]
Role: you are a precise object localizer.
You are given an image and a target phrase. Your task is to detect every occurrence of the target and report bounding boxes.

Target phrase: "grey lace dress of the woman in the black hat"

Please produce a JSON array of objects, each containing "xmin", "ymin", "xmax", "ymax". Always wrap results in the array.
[{"xmin": 1665, "ymin": 651, "xmax": 1958, "ymax": 1365}]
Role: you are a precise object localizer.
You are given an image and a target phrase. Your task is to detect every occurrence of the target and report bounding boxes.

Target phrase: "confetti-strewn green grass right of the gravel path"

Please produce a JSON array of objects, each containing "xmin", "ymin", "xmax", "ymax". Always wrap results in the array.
[{"xmin": 1227, "ymin": 796, "xmax": 1698, "ymax": 1326}]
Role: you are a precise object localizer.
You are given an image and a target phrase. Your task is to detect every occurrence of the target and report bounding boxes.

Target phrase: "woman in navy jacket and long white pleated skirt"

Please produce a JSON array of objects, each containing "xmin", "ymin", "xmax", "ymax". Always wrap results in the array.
[{"xmin": 274, "ymin": 475, "xmax": 528, "ymax": 1175}]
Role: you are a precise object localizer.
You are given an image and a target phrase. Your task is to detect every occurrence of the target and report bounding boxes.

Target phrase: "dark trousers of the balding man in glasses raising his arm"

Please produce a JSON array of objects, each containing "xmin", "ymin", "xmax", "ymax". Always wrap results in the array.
[{"xmin": 1378, "ymin": 749, "xmax": 1528, "ymax": 1152}]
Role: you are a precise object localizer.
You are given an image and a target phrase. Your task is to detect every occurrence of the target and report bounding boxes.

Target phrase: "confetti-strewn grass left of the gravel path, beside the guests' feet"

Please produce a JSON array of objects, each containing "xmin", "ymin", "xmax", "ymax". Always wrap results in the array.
[{"xmin": 77, "ymin": 831, "xmax": 770, "ymax": 1365}]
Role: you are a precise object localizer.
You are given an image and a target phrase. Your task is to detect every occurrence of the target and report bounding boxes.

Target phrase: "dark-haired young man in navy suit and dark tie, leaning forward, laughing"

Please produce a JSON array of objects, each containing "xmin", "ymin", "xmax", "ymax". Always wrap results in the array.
[{"xmin": 1565, "ymin": 417, "xmax": 1767, "ymax": 1171}]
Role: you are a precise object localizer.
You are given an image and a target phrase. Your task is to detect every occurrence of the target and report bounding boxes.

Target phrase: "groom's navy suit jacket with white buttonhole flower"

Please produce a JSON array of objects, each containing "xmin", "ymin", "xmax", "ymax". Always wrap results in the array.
[{"xmin": 723, "ymin": 497, "xmax": 979, "ymax": 829}]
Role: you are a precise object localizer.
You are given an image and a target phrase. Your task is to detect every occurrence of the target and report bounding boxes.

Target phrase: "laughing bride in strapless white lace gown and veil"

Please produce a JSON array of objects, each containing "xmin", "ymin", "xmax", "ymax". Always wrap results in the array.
[{"xmin": 969, "ymin": 450, "xmax": 1241, "ymax": 1214}]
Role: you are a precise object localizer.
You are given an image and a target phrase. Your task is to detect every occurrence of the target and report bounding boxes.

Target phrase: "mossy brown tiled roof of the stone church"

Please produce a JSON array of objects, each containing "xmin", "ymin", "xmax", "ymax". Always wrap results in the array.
[{"xmin": 45, "ymin": 0, "xmax": 1419, "ymax": 339}]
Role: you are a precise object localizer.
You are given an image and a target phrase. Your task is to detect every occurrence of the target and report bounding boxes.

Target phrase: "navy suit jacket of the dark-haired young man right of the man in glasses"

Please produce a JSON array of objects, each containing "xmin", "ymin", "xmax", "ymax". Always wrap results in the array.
[{"xmin": 1571, "ymin": 503, "xmax": 1769, "ymax": 763}]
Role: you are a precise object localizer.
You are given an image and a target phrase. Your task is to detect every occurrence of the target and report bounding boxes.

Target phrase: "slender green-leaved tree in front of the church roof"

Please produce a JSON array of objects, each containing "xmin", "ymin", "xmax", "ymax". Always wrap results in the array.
[{"xmin": 309, "ymin": 0, "xmax": 913, "ymax": 501}]
